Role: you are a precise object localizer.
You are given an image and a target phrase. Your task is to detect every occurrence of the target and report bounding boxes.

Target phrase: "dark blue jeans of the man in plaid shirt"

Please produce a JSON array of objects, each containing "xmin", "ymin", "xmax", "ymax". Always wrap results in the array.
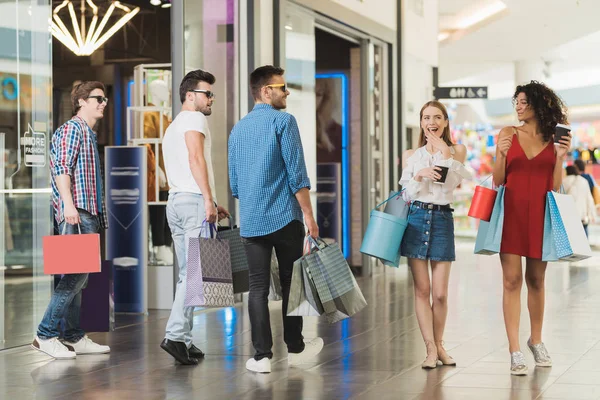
[{"xmin": 37, "ymin": 208, "xmax": 100, "ymax": 343}]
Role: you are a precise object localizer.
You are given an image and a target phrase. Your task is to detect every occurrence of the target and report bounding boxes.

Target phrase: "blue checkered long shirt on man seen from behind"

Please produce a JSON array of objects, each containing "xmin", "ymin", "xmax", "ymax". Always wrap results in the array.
[{"xmin": 229, "ymin": 104, "xmax": 310, "ymax": 237}]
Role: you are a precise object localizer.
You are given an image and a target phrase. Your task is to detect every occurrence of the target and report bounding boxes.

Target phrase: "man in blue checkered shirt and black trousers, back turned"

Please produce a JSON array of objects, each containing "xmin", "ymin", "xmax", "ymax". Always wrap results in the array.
[{"xmin": 229, "ymin": 65, "xmax": 323, "ymax": 373}]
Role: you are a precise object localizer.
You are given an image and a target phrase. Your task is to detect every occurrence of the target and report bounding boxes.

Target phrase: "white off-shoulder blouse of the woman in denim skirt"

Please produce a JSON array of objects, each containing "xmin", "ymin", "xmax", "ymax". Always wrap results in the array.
[{"xmin": 400, "ymin": 146, "xmax": 471, "ymax": 205}]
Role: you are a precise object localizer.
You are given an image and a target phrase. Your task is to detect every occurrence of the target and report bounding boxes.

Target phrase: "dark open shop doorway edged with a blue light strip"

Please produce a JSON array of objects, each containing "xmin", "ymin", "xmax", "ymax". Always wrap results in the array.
[{"xmin": 315, "ymin": 28, "xmax": 361, "ymax": 258}]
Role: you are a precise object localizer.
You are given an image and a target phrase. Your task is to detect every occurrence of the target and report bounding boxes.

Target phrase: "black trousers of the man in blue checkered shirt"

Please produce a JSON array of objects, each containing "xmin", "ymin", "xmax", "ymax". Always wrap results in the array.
[{"xmin": 242, "ymin": 220, "xmax": 304, "ymax": 361}]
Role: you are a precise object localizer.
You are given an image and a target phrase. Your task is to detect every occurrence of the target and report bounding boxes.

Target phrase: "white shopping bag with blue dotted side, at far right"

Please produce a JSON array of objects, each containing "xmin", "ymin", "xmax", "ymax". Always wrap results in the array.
[{"xmin": 542, "ymin": 192, "xmax": 592, "ymax": 262}]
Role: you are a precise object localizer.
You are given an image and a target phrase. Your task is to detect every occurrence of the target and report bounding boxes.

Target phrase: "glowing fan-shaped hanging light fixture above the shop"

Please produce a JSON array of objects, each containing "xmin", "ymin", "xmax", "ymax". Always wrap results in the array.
[{"xmin": 50, "ymin": 0, "xmax": 140, "ymax": 56}]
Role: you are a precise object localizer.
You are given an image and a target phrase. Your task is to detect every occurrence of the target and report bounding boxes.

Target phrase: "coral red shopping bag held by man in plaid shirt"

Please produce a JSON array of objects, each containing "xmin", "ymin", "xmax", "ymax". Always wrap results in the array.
[{"xmin": 42, "ymin": 228, "xmax": 101, "ymax": 275}]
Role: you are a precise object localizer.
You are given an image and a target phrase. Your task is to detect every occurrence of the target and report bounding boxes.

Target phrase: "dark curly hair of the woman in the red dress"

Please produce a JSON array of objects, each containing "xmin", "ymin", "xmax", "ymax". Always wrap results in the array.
[{"xmin": 513, "ymin": 81, "xmax": 569, "ymax": 142}]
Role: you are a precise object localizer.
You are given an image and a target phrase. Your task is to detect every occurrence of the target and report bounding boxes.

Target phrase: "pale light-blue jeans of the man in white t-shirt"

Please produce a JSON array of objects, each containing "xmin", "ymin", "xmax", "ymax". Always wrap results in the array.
[{"xmin": 165, "ymin": 192, "xmax": 210, "ymax": 348}]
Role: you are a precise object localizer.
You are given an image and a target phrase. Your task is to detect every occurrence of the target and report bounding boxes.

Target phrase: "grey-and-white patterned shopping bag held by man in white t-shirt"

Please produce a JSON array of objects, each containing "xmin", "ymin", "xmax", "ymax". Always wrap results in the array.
[{"xmin": 184, "ymin": 224, "xmax": 234, "ymax": 307}]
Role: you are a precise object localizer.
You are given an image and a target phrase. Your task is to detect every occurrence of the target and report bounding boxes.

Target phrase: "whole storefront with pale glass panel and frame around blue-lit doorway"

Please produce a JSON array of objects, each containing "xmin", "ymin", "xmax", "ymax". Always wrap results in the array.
[{"xmin": 281, "ymin": 2, "xmax": 391, "ymax": 275}]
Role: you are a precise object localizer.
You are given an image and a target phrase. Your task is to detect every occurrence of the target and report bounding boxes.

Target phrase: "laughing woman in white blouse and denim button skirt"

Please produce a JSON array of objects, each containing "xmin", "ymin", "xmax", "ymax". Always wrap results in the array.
[{"xmin": 400, "ymin": 101, "xmax": 470, "ymax": 369}]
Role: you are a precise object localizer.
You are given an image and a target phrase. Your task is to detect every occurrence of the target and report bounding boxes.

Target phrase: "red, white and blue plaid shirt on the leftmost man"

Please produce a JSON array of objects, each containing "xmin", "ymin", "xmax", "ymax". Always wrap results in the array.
[{"xmin": 50, "ymin": 116, "xmax": 108, "ymax": 228}]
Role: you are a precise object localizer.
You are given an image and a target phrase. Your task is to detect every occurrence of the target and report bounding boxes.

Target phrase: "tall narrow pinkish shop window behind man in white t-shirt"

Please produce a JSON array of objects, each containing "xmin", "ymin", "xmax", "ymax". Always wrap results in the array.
[{"xmin": 184, "ymin": 0, "xmax": 239, "ymax": 206}]
